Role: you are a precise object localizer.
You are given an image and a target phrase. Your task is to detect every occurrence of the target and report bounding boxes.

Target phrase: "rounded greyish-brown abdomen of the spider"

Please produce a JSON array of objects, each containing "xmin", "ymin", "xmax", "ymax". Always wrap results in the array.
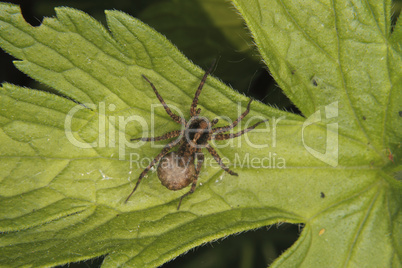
[{"xmin": 157, "ymin": 152, "xmax": 195, "ymax": 191}]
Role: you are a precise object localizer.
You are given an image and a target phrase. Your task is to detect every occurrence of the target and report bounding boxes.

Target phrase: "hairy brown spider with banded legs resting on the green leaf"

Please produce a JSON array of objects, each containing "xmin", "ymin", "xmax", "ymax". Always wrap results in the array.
[{"xmin": 125, "ymin": 65, "xmax": 268, "ymax": 210}]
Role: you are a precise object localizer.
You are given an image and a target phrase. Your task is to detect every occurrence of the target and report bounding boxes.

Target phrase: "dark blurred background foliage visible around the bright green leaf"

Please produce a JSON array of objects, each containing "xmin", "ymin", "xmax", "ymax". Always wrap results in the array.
[{"xmin": 0, "ymin": 0, "xmax": 402, "ymax": 268}]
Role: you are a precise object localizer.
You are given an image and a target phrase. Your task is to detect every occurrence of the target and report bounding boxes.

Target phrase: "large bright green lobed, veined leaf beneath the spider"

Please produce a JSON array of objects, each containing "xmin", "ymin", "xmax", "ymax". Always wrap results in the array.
[{"xmin": 0, "ymin": 0, "xmax": 402, "ymax": 267}]
